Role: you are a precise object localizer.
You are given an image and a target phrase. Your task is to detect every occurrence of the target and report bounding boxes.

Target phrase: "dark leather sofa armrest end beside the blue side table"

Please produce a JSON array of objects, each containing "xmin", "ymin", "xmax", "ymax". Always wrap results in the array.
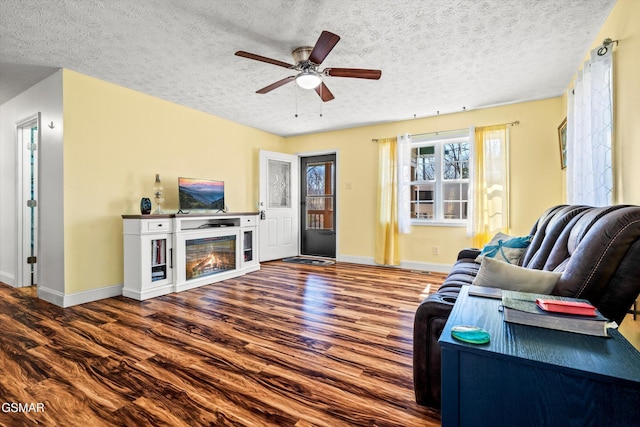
[{"xmin": 413, "ymin": 291, "xmax": 458, "ymax": 409}]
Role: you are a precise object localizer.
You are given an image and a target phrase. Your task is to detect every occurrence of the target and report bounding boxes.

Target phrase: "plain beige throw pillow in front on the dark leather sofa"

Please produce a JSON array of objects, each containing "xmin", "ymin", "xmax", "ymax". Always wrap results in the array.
[{"xmin": 472, "ymin": 257, "xmax": 562, "ymax": 294}]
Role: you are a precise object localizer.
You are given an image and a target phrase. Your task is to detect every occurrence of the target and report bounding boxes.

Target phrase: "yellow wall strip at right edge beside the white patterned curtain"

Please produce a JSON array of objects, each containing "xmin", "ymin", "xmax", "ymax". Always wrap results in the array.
[{"xmin": 591, "ymin": 0, "xmax": 640, "ymax": 205}]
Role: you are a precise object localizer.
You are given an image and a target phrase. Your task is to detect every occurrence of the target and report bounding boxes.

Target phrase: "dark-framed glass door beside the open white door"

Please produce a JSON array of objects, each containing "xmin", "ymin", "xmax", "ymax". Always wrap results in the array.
[{"xmin": 300, "ymin": 153, "xmax": 337, "ymax": 258}]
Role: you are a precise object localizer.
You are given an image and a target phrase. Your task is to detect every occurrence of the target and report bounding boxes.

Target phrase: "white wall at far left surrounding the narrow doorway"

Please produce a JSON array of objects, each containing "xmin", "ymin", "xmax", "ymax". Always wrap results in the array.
[{"xmin": 0, "ymin": 70, "xmax": 64, "ymax": 302}]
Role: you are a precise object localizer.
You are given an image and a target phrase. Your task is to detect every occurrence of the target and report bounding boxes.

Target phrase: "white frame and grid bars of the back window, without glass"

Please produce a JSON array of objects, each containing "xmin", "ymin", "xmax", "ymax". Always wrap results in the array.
[{"xmin": 409, "ymin": 130, "xmax": 473, "ymax": 227}]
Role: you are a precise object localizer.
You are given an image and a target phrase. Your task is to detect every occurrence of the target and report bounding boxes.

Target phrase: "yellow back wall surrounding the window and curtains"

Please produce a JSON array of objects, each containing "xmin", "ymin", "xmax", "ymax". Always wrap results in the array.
[{"xmin": 287, "ymin": 97, "xmax": 564, "ymax": 264}]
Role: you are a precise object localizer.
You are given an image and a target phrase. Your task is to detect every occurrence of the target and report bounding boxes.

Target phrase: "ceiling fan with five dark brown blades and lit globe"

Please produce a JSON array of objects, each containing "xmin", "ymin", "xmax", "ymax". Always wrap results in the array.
[{"xmin": 236, "ymin": 31, "xmax": 382, "ymax": 102}]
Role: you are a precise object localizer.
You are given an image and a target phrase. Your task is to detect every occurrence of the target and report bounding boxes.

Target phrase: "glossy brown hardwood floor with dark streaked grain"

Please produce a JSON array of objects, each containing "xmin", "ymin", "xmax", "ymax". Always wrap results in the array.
[{"xmin": 0, "ymin": 262, "xmax": 444, "ymax": 427}]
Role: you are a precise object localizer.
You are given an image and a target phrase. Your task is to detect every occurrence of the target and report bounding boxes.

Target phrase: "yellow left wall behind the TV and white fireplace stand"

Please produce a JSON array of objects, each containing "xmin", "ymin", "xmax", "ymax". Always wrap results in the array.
[{"xmin": 63, "ymin": 70, "xmax": 285, "ymax": 294}]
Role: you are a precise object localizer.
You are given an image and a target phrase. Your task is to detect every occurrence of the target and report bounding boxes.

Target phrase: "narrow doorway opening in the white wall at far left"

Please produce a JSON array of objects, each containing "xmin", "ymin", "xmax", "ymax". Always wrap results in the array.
[{"xmin": 16, "ymin": 114, "xmax": 40, "ymax": 287}]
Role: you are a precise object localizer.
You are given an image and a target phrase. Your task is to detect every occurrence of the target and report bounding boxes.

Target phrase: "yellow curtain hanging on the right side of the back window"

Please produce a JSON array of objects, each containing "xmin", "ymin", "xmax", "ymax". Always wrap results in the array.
[{"xmin": 471, "ymin": 125, "xmax": 509, "ymax": 248}]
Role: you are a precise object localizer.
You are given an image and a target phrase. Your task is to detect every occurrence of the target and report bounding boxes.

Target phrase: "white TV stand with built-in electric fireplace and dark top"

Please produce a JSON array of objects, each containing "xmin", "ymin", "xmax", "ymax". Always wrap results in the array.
[{"xmin": 122, "ymin": 212, "xmax": 260, "ymax": 300}]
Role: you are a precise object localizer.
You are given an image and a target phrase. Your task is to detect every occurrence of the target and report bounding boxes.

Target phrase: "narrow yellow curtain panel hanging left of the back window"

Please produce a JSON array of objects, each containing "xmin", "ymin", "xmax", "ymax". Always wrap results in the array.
[{"xmin": 374, "ymin": 138, "xmax": 400, "ymax": 265}]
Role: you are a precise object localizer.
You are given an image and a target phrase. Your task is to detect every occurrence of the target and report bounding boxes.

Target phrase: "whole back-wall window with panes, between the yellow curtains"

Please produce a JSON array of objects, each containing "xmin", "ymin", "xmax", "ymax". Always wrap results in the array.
[{"xmin": 410, "ymin": 131, "xmax": 471, "ymax": 224}]
